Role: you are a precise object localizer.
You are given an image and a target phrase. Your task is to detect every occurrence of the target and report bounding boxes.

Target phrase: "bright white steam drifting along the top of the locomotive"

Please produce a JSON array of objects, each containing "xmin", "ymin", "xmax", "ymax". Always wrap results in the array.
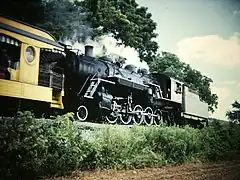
[{"xmin": 64, "ymin": 35, "xmax": 149, "ymax": 70}]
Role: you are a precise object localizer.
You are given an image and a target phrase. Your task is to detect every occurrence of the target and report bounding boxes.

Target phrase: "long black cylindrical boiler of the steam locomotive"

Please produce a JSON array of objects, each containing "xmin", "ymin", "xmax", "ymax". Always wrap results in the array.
[{"xmin": 63, "ymin": 48, "xmax": 157, "ymax": 90}]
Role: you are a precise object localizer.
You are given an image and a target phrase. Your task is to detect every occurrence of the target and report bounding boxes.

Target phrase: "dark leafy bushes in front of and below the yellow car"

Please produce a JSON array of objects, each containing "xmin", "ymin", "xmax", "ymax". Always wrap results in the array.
[{"xmin": 0, "ymin": 112, "xmax": 92, "ymax": 179}]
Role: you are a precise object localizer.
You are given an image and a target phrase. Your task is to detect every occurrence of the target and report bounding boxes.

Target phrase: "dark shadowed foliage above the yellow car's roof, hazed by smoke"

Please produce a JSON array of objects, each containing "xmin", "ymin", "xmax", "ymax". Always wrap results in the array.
[{"xmin": 0, "ymin": 0, "xmax": 87, "ymax": 42}]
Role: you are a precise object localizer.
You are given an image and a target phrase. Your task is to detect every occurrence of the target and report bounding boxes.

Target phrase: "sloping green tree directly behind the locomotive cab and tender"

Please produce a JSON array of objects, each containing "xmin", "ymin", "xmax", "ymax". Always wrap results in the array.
[{"xmin": 149, "ymin": 52, "xmax": 218, "ymax": 112}]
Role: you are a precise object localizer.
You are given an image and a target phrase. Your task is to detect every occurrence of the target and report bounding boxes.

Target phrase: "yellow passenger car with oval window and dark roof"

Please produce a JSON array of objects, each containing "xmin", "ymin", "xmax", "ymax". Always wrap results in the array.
[{"xmin": 0, "ymin": 16, "xmax": 65, "ymax": 116}]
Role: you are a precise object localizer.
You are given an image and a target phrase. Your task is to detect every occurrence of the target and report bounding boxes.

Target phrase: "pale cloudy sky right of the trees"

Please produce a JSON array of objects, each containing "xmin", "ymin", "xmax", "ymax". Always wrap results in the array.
[{"xmin": 133, "ymin": 0, "xmax": 240, "ymax": 119}]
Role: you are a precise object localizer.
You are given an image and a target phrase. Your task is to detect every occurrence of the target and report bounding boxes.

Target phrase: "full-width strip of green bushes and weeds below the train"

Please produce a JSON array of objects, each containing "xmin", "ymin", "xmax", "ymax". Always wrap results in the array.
[{"xmin": 0, "ymin": 112, "xmax": 240, "ymax": 179}]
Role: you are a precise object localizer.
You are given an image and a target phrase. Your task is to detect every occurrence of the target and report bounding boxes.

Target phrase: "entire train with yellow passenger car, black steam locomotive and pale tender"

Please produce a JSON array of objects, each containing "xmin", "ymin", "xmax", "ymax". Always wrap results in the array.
[{"xmin": 0, "ymin": 16, "xmax": 208, "ymax": 126}]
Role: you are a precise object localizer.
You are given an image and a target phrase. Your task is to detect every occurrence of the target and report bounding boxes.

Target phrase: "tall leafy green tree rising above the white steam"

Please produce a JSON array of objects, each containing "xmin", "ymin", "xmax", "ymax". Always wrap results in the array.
[{"xmin": 75, "ymin": 0, "xmax": 158, "ymax": 63}]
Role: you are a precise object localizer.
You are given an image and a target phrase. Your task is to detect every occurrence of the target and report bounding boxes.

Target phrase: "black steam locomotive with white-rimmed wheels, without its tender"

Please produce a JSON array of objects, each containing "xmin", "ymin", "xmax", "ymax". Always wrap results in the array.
[{"xmin": 57, "ymin": 46, "xmax": 205, "ymax": 125}]
